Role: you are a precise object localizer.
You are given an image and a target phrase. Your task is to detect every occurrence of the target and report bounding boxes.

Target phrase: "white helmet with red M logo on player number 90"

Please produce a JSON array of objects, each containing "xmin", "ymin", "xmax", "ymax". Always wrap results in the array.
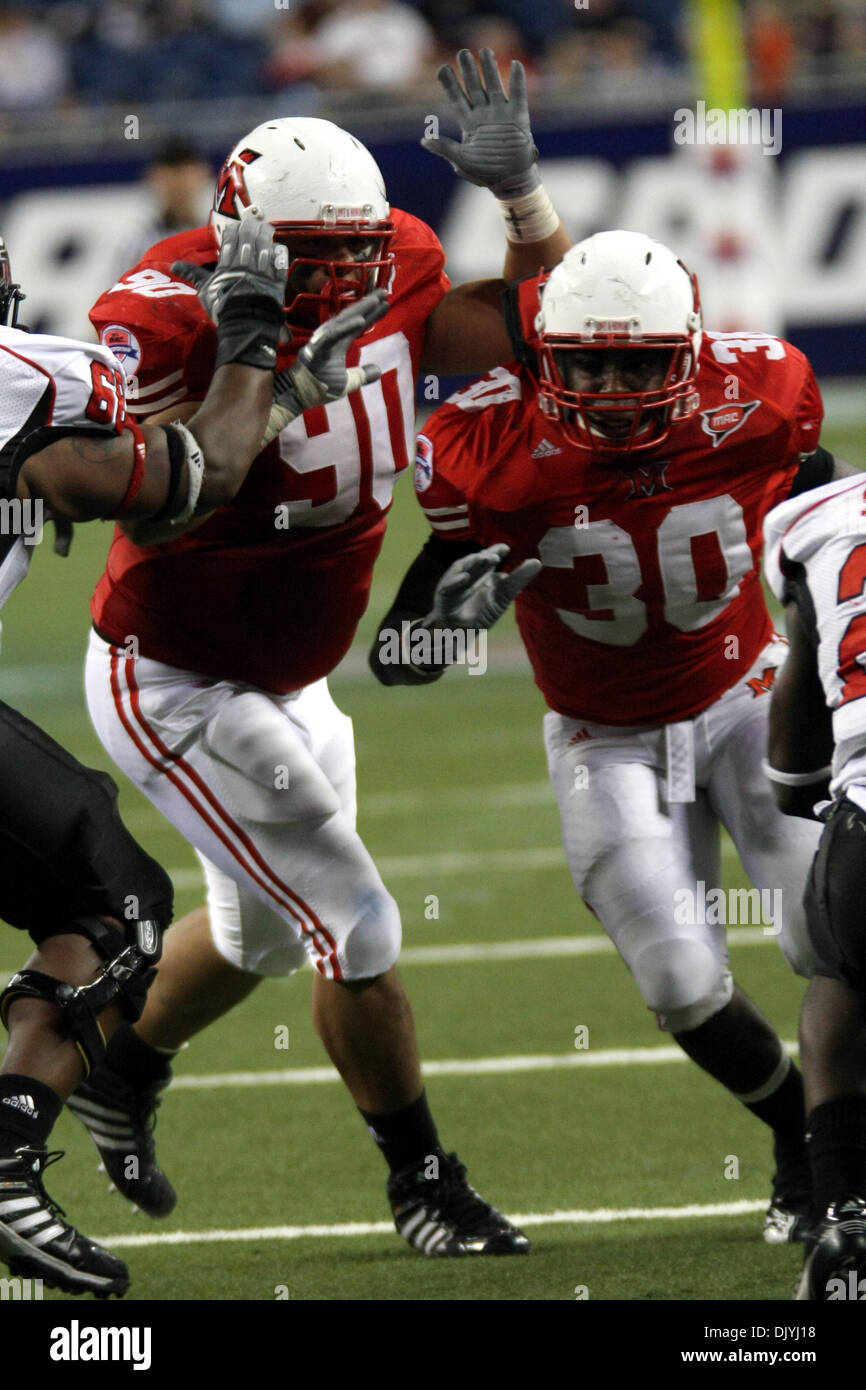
[{"xmin": 211, "ymin": 115, "xmax": 393, "ymax": 341}]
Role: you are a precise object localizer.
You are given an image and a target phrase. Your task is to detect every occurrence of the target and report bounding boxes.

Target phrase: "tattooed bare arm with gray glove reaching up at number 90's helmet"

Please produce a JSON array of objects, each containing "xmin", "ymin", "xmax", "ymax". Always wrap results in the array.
[{"xmin": 18, "ymin": 215, "xmax": 288, "ymax": 543}]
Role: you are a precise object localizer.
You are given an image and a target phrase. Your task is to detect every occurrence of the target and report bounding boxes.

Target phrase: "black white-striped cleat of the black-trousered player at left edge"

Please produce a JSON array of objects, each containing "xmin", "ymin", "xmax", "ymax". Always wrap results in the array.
[{"xmin": 0, "ymin": 1147, "xmax": 129, "ymax": 1298}]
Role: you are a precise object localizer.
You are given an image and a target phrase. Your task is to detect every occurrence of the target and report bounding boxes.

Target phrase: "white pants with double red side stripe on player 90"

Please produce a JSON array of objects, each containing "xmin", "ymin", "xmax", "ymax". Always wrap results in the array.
[{"xmin": 85, "ymin": 632, "xmax": 400, "ymax": 980}]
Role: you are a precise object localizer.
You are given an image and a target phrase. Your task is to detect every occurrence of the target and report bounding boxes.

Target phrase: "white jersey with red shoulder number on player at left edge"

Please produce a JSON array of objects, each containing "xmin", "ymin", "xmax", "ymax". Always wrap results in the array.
[{"xmin": 0, "ymin": 327, "xmax": 126, "ymax": 607}]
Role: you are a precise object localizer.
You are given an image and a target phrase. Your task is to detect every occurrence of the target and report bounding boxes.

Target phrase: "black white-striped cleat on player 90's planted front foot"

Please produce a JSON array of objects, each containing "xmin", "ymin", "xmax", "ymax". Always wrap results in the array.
[{"xmin": 388, "ymin": 1152, "xmax": 531, "ymax": 1257}]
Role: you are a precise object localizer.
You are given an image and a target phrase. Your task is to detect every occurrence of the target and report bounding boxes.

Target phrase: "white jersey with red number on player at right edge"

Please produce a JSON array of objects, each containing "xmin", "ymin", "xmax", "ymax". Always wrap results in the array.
[{"xmin": 765, "ymin": 477, "xmax": 866, "ymax": 810}]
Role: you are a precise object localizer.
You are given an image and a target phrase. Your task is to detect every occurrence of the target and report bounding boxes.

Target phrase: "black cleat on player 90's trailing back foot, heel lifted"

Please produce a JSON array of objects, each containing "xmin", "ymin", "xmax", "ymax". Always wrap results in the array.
[{"xmin": 67, "ymin": 1066, "xmax": 178, "ymax": 1216}]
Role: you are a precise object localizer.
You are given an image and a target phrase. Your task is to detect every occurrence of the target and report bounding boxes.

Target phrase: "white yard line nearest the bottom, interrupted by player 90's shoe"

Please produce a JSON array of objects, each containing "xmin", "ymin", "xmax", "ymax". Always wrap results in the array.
[{"xmin": 93, "ymin": 1198, "xmax": 767, "ymax": 1250}]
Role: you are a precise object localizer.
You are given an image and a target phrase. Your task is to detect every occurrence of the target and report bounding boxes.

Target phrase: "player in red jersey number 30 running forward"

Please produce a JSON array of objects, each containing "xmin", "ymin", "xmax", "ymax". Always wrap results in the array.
[{"xmin": 371, "ymin": 231, "xmax": 856, "ymax": 1241}]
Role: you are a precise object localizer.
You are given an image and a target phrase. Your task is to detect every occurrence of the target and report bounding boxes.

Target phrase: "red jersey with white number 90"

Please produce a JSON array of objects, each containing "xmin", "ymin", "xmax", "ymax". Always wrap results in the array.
[{"xmin": 90, "ymin": 209, "xmax": 449, "ymax": 694}]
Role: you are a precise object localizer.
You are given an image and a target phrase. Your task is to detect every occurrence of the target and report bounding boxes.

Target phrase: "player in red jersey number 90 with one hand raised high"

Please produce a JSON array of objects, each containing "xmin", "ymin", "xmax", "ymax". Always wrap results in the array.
[{"xmin": 71, "ymin": 50, "xmax": 569, "ymax": 1257}]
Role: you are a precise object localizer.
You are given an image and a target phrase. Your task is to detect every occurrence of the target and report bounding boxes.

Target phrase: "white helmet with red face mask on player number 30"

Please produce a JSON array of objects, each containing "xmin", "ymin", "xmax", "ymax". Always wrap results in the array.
[{"xmin": 535, "ymin": 231, "xmax": 701, "ymax": 453}]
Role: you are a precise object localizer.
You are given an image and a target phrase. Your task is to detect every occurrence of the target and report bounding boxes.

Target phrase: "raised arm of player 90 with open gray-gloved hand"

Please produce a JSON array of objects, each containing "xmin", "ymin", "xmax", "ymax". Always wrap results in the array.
[{"xmin": 421, "ymin": 49, "xmax": 571, "ymax": 373}]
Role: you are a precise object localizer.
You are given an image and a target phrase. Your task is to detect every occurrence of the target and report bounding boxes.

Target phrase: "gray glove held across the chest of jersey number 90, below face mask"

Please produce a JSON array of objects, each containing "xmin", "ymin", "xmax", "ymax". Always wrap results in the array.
[{"xmin": 261, "ymin": 289, "xmax": 388, "ymax": 448}]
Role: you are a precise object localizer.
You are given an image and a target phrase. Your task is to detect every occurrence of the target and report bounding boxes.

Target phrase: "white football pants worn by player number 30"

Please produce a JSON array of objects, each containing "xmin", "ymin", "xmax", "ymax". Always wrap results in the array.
[{"xmin": 544, "ymin": 639, "xmax": 822, "ymax": 1033}]
